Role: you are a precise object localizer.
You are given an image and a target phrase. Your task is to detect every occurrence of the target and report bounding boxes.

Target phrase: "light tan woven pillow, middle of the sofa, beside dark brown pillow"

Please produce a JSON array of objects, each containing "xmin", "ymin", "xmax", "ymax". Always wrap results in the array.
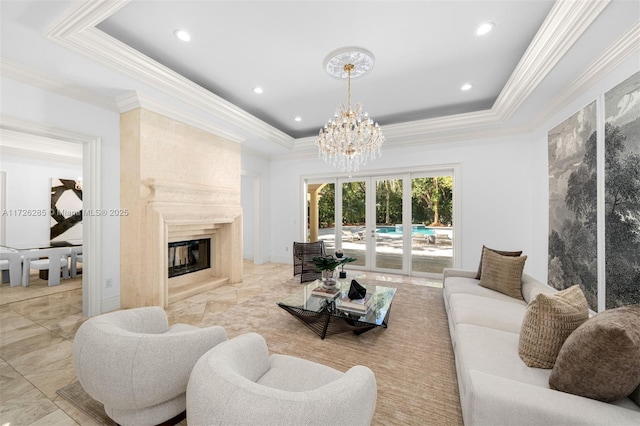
[{"xmin": 518, "ymin": 285, "xmax": 589, "ymax": 368}]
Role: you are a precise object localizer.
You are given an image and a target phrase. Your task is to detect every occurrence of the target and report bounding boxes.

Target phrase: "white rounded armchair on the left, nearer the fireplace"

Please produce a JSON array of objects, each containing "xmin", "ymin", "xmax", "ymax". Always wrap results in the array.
[{"xmin": 73, "ymin": 307, "xmax": 227, "ymax": 426}]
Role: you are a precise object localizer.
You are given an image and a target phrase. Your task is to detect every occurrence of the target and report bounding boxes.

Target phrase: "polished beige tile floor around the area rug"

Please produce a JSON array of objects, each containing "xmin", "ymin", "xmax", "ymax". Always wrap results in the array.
[{"xmin": 0, "ymin": 262, "xmax": 440, "ymax": 426}]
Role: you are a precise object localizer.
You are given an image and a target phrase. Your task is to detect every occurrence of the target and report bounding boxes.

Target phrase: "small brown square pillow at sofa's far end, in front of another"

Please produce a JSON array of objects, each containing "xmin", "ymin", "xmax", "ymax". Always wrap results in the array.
[{"xmin": 479, "ymin": 248, "xmax": 527, "ymax": 300}]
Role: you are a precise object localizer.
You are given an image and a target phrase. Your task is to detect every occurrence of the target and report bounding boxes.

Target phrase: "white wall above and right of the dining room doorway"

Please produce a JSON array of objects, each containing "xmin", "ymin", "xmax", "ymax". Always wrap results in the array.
[{"xmin": 1, "ymin": 77, "xmax": 120, "ymax": 310}]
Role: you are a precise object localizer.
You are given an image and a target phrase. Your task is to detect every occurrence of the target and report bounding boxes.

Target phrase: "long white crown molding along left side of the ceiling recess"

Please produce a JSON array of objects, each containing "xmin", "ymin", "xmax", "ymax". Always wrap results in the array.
[{"xmin": 45, "ymin": 1, "xmax": 295, "ymax": 149}]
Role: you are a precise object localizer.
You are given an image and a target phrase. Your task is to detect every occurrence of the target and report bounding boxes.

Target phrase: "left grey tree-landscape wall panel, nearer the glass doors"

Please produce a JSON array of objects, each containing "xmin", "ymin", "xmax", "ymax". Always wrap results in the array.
[{"xmin": 548, "ymin": 102, "xmax": 598, "ymax": 310}]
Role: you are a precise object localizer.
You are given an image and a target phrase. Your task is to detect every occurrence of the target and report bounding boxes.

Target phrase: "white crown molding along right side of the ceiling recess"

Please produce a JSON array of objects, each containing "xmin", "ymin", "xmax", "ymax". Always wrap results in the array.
[{"xmin": 492, "ymin": 0, "xmax": 611, "ymax": 121}]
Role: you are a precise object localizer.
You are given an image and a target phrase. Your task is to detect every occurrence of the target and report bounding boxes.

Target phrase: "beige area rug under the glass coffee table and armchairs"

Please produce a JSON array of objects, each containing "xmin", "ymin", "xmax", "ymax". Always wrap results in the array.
[{"xmin": 58, "ymin": 282, "xmax": 463, "ymax": 425}]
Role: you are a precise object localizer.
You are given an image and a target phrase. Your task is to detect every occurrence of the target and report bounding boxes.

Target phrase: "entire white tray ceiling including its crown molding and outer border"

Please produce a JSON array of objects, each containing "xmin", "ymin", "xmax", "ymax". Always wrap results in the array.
[{"xmin": 0, "ymin": 0, "xmax": 640, "ymax": 155}]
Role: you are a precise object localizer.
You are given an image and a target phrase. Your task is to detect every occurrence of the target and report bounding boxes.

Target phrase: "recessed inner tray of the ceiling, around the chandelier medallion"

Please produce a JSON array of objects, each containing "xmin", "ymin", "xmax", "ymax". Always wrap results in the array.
[{"xmin": 98, "ymin": 0, "xmax": 553, "ymax": 138}]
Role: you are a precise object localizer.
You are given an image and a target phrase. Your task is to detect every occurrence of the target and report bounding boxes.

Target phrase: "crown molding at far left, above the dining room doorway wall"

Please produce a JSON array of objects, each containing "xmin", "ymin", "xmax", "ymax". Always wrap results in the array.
[{"xmin": 0, "ymin": 58, "xmax": 118, "ymax": 111}]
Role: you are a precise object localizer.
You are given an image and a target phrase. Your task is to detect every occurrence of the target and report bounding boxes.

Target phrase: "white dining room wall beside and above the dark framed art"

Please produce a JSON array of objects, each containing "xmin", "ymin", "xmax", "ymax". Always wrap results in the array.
[{"xmin": 0, "ymin": 154, "xmax": 82, "ymax": 247}]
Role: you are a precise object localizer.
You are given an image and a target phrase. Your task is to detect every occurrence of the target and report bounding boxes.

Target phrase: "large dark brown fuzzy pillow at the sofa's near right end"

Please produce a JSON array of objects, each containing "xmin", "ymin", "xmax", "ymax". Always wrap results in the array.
[{"xmin": 549, "ymin": 305, "xmax": 640, "ymax": 402}]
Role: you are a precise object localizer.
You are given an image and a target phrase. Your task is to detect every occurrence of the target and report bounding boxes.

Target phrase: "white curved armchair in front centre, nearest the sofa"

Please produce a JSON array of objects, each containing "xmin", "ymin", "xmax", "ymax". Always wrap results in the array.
[{"xmin": 187, "ymin": 333, "xmax": 377, "ymax": 426}]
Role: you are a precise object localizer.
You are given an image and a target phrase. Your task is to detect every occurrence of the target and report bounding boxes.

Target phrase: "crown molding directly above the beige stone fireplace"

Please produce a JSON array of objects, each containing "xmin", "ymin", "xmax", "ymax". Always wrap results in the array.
[{"xmin": 116, "ymin": 91, "xmax": 245, "ymax": 143}]
